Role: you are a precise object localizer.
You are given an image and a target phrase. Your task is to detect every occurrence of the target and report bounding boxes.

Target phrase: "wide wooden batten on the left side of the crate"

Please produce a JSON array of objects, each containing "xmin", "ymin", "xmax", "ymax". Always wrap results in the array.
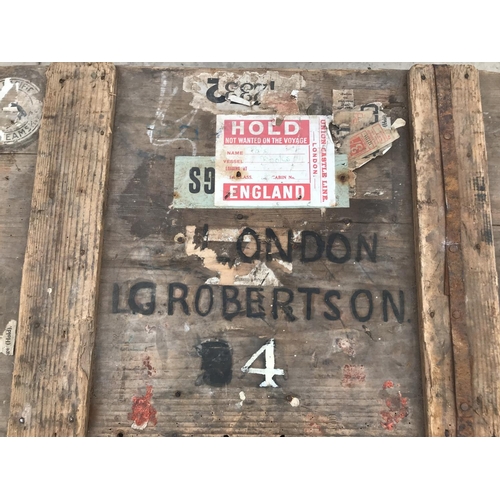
[{"xmin": 8, "ymin": 63, "xmax": 116, "ymax": 436}]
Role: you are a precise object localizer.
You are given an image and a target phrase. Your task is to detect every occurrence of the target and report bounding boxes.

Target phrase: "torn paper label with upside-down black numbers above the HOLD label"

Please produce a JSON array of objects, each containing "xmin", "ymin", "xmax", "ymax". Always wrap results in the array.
[{"xmin": 183, "ymin": 71, "xmax": 305, "ymax": 114}]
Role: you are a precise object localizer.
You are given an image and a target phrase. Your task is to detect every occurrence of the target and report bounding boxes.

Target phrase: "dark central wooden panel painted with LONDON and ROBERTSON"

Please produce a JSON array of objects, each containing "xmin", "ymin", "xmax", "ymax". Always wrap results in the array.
[{"xmin": 89, "ymin": 67, "xmax": 424, "ymax": 436}]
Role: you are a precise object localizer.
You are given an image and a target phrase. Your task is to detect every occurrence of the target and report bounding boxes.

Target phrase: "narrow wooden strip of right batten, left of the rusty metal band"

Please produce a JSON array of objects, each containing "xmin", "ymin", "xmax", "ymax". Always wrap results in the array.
[{"xmin": 409, "ymin": 65, "xmax": 456, "ymax": 436}]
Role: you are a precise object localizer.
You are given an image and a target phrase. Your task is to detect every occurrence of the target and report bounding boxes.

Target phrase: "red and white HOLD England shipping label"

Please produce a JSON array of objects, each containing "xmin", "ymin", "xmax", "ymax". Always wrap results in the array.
[{"xmin": 214, "ymin": 115, "xmax": 335, "ymax": 207}]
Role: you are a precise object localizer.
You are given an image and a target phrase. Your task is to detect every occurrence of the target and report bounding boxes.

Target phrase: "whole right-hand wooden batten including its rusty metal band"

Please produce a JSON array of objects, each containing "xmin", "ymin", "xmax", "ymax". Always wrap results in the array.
[{"xmin": 409, "ymin": 65, "xmax": 500, "ymax": 436}]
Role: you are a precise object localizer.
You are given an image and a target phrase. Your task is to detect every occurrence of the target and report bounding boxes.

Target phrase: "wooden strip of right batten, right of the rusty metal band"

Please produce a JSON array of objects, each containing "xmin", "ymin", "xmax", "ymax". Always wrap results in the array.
[{"xmin": 450, "ymin": 65, "xmax": 500, "ymax": 436}]
